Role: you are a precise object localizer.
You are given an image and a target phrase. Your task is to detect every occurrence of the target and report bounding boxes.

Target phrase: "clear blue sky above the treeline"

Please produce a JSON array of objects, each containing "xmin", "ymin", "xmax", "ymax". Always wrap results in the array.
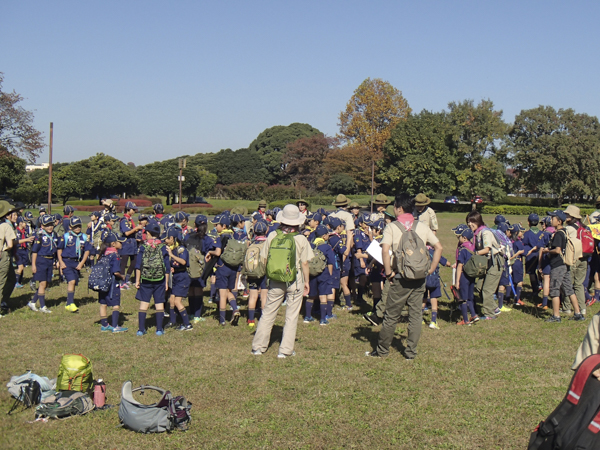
[{"xmin": 0, "ymin": 0, "xmax": 600, "ymax": 165}]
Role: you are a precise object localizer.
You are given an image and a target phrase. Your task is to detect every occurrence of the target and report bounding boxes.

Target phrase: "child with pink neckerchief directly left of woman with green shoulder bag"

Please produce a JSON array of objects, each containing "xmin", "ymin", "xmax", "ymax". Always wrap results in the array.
[{"xmin": 452, "ymin": 225, "xmax": 479, "ymax": 326}]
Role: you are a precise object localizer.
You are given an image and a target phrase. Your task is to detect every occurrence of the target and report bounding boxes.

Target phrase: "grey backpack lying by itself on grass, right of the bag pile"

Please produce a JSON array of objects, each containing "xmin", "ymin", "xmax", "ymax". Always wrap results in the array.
[{"xmin": 119, "ymin": 381, "xmax": 192, "ymax": 433}]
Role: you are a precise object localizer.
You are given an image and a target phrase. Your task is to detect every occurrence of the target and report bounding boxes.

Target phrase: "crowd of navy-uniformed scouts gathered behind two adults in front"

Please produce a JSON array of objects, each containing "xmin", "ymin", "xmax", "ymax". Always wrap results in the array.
[{"xmin": 2, "ymin": 194, "xmax": 600, "ymax": 346}]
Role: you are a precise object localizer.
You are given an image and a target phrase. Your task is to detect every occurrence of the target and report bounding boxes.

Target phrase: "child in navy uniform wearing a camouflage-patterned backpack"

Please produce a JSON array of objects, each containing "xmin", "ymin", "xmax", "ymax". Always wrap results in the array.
[{"xmin": 134, "ymin": 220, "xmax": 171, "ymax": 336}]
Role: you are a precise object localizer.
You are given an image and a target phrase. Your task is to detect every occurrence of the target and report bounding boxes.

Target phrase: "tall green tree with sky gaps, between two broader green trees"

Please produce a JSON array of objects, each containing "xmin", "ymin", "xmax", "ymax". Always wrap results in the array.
[{"xmin": 446, "ymin": 100, "xmax": 507, "ymax": 199}]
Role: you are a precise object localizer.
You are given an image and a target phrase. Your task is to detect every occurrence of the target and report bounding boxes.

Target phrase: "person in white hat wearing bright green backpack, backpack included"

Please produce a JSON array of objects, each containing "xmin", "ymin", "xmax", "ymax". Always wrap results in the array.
[{"xmin": 252, "ymin": 205, "xmax": 314, "ymax": 358}]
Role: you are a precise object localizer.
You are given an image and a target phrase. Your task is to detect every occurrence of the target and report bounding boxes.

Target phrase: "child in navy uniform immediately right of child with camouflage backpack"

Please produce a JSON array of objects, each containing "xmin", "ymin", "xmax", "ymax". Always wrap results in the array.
[{"xmin": 165, "ymin": 227, "xmax": 194, "ymax": 331}]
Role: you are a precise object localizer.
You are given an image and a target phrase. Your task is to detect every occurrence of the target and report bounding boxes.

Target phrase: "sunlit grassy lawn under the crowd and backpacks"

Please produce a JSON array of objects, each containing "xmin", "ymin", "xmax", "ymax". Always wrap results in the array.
[{"xmin": 0, "ymin": 213, "xmax": 599, "ymax": 449}]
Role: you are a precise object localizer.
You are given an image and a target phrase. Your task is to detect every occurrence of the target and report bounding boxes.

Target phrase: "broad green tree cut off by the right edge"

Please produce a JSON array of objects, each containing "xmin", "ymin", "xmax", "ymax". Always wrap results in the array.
[{"xmin": 508, "ymin": 106, "xmax": 600, "ymax": 204}]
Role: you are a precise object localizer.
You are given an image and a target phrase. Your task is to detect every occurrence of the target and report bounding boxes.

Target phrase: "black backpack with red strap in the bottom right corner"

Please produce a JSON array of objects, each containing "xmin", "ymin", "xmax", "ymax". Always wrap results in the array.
[{"xmin": 527, "ymin": 354, "xmax": 600, "ymax": 450}]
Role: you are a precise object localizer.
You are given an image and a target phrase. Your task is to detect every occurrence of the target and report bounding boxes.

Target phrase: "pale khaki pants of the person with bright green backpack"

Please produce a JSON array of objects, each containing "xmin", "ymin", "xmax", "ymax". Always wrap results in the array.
[{"xmin": 252, "ymin": 280, "xmax": 304, "ymax": 356}]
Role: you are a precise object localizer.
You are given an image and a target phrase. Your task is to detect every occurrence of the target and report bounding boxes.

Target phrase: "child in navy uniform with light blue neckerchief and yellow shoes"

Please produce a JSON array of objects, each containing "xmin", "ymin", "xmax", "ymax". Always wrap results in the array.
[{"xmin": 57, "ymin": 217, "xmax": 92, "ymax": 312}]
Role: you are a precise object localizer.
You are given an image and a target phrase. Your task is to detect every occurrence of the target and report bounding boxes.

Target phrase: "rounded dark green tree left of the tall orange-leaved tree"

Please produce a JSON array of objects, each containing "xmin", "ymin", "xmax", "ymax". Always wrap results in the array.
[{"xmin": 248, "ymin": 123, "xmax": 323, "ymax": 184}]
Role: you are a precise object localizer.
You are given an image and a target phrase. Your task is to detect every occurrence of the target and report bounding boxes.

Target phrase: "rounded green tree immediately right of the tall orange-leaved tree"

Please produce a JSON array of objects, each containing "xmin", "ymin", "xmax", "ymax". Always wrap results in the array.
[{"xmin": 379, "ymin": 110, "xmax": 457, "ymax": 195}]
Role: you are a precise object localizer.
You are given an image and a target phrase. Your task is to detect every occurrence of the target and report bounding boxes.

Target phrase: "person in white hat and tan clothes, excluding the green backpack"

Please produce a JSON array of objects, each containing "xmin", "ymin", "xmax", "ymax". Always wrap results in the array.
[{"xmin": 252, "ymin": 205, "xmax": 315, "ymax": 358}]
